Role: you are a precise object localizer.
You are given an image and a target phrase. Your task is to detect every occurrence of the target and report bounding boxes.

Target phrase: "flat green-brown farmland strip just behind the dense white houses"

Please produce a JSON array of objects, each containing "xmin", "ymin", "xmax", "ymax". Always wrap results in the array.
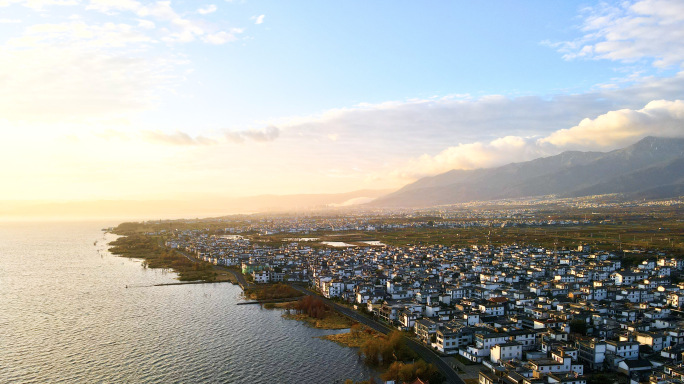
[{"xmin": 253, "ymin": 207, "xmax": 684, "ymax": 255}]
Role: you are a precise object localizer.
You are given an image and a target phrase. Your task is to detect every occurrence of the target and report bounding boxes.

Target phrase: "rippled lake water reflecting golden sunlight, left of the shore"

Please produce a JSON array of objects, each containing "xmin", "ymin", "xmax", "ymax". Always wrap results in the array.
[{"xmin": 0, "ymin": 223, "xmax": 372, "ymax": 383}]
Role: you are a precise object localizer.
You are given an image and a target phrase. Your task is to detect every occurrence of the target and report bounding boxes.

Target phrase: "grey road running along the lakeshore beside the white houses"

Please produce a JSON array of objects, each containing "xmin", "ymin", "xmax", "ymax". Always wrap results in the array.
[{"xmin": 292, "ymin": 285, "xmax": 465, "ymax": 384}]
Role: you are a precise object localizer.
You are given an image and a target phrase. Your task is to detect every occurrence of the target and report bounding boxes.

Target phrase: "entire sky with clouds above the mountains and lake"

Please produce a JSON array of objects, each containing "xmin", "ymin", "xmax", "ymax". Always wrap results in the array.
[{"xmin": 0, "ymin": 0, "xmax": 684, "ymax": 202}]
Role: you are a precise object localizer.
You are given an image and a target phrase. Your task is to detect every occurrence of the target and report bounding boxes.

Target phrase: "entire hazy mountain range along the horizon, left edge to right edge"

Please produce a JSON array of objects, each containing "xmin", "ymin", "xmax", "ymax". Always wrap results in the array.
[{"xmin": 6, "ymin": 137, "xmax": 684, "ymax": 219}]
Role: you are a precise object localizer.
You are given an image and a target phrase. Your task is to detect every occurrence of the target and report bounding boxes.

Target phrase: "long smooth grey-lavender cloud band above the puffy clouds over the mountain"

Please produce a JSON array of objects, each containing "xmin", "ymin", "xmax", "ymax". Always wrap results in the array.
[{"xmin": 267, "ymin": 73, "xmax": 684, "ymax": 154}]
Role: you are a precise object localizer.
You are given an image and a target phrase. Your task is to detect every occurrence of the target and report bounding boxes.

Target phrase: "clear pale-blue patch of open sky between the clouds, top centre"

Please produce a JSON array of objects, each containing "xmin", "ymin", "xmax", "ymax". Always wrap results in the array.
[{"xmin": 154, "ymin": 1, "xmax": 615, "ymax": 130}]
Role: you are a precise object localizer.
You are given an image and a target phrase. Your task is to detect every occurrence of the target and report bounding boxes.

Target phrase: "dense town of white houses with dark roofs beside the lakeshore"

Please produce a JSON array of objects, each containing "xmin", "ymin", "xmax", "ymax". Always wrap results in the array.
[{"xmin": 166, "ymin": 226, "xmax": 684, "ymax": 384}]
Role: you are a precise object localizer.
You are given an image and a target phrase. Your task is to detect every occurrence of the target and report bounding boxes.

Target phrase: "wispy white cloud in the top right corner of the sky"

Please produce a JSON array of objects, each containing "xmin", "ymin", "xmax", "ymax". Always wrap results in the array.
[{"xmin": 550, "ymin": 0, "xmax": 684, "ymax": 68}]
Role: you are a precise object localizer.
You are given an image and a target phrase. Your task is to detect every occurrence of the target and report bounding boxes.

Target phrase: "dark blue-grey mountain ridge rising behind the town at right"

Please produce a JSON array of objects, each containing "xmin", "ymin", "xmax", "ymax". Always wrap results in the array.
[{"xmin": 370, "ymin": 137, "xmax": 684, "ymax": 207}]
